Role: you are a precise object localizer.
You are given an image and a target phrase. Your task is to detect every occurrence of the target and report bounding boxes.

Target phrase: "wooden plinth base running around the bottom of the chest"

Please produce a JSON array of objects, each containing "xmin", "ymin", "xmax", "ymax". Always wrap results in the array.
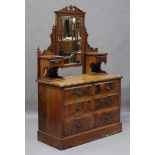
[{"xmin": 38, "ymin": 123, "xmax": 122, "ymax": 150}]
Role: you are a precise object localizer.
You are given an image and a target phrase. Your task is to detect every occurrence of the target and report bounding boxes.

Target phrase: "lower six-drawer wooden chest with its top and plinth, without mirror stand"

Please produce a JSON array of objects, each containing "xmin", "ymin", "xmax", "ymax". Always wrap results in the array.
[{"xmin": 38, "ymin": 74, "xmax": 122, "ymax": 149}]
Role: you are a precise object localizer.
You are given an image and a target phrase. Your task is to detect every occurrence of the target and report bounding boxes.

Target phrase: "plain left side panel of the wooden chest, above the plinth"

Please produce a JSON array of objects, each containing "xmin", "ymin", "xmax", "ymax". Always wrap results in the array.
[{"xmin": 38, "ymin": 84, "xmax": 63, "ymax": 137}]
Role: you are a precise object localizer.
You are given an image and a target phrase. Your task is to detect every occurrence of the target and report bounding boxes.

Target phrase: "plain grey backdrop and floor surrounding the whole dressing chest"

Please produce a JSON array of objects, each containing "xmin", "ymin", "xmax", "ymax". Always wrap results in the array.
[{"xmin": 25, "ymin": 0, "xmax": 130, "ymax": 155}]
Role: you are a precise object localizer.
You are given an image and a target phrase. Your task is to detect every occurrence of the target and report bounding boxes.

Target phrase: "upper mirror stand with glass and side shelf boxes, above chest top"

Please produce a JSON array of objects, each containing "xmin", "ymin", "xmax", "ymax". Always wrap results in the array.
[{"xmin": 37, "ymin": 6, "xmax": 108, "ymax": 79}]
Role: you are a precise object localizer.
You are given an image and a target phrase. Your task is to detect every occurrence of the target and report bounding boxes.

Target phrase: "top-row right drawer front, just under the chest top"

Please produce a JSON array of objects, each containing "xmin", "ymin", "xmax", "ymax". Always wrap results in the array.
[{"xmin": 95, "ymin": 81, "xmax": 119, "ymax": 95}]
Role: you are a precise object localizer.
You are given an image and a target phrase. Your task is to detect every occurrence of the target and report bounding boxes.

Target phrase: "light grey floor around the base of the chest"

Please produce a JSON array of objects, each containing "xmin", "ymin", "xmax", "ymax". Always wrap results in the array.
[{"xmin": 25, "ymin": 112, "xmax": 130, "ymax": 155}]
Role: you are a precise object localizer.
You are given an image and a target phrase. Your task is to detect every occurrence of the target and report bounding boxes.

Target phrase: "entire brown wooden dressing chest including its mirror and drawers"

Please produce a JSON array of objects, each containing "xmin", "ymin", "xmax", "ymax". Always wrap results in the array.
[{"xmin": 37, "ymin": 6, "xmax": 122, "ymax": 149}]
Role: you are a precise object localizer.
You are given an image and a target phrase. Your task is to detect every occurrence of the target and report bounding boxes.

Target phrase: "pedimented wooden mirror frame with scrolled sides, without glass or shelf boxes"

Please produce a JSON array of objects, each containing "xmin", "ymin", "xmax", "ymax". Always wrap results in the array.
[{"xmin": 46, "ymin": 6, "xmax": 98, "ymax": 73}]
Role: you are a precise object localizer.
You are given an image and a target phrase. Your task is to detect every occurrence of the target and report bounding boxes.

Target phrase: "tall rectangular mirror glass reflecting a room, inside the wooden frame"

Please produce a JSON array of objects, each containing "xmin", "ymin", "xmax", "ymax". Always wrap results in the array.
[{"xmin": 58, "ymin": 16, "xmax": 82, "ymax": 64}]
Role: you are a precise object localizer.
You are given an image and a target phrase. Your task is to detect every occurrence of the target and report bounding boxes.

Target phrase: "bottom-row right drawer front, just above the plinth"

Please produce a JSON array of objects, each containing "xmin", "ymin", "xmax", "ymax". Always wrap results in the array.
[{"xmin": 95, "ymin": 110, "xmax": 120, "ymax": 127}]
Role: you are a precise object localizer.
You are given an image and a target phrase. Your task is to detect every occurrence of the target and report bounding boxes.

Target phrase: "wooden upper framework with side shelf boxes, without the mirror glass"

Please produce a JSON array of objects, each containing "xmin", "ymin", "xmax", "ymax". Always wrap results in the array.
[{"xmin": 37, "ymin": 6, "xmax": 108, "ymax": 79}]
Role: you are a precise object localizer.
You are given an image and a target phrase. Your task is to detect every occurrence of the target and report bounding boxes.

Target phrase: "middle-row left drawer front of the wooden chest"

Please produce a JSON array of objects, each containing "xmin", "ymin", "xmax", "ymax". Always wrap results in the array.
[{"xmin": 64, "ymin": 100, "xmax": 94, "ymax": 118}]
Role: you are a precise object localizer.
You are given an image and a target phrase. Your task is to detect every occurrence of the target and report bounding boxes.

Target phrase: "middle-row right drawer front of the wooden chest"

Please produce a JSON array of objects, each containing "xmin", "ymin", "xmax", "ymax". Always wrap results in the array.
[{"xmin": 94, "ymin": 95, "xmax": 119, "ymax": 110}]
